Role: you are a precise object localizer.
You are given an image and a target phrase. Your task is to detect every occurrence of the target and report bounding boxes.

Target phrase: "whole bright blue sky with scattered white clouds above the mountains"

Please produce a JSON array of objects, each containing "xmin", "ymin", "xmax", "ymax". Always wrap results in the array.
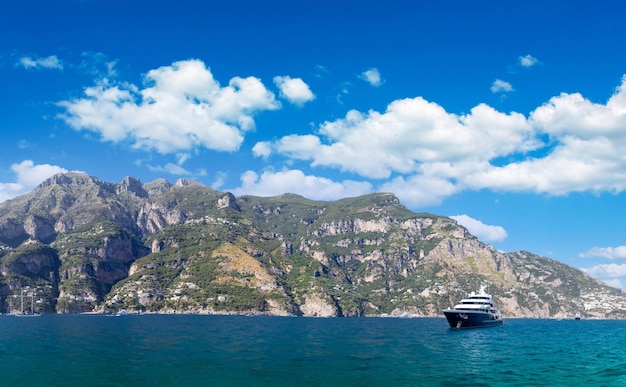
[{"xmin": 0, "ymin": 0, "xmax": 626, "ymax": 288}]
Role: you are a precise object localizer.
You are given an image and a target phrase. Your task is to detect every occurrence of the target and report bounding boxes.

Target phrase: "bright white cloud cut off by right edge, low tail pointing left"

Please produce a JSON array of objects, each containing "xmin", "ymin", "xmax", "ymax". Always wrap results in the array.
[{"xmin": 464, "ymin": 77, "xmax": 626, "ymax": 195}]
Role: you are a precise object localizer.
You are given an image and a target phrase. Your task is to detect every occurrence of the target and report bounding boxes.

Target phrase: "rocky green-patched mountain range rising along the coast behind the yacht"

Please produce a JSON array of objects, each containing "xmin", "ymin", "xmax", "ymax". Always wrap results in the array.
[{"xmin": 0, "ymin": 174, "xmax": 626, "ymax": 318}]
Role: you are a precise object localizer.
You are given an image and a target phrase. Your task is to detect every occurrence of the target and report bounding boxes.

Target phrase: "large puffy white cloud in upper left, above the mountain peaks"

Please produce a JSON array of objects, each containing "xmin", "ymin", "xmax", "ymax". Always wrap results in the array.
[{"xmin": 59, "ymin": 60, "xmax": 280, "ymax": 154}]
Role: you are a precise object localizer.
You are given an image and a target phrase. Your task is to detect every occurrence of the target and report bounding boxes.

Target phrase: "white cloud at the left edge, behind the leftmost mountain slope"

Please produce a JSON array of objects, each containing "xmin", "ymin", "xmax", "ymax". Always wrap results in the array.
[{"xmin": 0, "ymin": 160, "xmax": 68, "ymax": 203}]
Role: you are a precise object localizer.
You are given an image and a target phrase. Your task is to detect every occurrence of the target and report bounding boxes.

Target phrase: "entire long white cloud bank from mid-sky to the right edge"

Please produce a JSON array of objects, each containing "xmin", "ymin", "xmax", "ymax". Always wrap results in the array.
[{"xmin": 264, "ymin": 74, "xmax": 626, "ymax": 206}]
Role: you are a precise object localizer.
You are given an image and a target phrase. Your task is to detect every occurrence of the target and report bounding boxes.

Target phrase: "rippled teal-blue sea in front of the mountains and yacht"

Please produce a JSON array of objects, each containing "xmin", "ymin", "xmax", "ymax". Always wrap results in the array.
[{"xmin": 0, "ymin": 315, "xmax": 626, "ymax": 386}]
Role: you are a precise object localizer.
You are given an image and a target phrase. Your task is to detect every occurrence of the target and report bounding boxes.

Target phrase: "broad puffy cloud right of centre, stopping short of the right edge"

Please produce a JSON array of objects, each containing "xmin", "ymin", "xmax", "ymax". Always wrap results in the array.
[{"xmin": 274, "ymin": 97, "xmax": 539, "ymax": 179}]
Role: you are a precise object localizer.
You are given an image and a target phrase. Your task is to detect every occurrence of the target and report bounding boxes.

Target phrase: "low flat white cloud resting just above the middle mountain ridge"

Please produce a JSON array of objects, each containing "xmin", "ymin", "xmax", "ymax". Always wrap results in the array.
[{"xmin": 229, "ymin": 169, "xmax": 372, "ymax": 200}]
